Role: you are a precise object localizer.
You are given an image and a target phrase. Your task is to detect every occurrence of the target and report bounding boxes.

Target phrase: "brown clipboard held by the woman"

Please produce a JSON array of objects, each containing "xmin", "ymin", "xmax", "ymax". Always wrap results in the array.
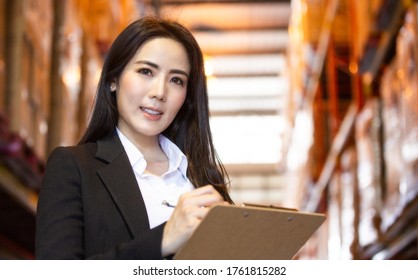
[{"xmin": 173, "ymin": 205, "xmax": 326, "ymax": 260}]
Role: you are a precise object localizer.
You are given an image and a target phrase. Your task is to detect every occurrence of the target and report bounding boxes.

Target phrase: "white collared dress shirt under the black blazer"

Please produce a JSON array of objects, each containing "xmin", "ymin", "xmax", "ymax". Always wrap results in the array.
[{"xmin": 117, "ymin": 129, "xmax": 194, "ymax": 228}]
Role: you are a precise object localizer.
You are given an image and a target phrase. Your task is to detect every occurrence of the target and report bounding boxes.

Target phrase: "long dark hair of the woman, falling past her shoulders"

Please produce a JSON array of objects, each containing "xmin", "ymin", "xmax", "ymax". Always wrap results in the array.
[{"xmin": 79, "ymin": 17, "xmax": 232, "ymax": 202}]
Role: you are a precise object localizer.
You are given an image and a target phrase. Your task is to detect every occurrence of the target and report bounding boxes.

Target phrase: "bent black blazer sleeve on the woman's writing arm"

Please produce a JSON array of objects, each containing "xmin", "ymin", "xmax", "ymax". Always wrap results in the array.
[{"xmin": 35, "ymin": 147, "xmax": 165, "ymax": 259}]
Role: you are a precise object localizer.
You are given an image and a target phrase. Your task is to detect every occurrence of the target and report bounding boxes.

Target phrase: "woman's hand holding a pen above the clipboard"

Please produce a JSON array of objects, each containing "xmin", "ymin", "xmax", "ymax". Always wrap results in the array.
[{"xmin": 161, "ymin": 185, "xmax": 228, "ymax": 257}]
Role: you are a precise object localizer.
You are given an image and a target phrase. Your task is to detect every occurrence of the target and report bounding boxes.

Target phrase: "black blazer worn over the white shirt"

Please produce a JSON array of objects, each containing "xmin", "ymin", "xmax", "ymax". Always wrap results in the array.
[{"xmin": 35, "ymin": 131, "xmax": 164, "ymax": 259}]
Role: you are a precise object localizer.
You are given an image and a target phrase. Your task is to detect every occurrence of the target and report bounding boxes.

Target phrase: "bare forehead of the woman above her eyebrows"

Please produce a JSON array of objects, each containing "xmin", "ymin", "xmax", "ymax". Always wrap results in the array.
[{"xmin": 132, "ymin": 37, "xmax": 190, "ymax": 72}]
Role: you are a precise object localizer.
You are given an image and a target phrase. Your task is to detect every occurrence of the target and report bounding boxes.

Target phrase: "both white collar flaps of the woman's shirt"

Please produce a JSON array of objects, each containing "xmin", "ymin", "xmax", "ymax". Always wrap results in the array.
[{"xmin": 116, "ymin": 128, "xmax": 187, "ymax": 178}]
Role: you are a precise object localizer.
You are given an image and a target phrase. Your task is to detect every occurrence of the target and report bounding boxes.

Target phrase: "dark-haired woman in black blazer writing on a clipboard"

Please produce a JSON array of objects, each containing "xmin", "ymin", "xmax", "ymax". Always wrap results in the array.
[{"xmin": 36, "ymin": 18, "xmax": 232, "ymax": 259}]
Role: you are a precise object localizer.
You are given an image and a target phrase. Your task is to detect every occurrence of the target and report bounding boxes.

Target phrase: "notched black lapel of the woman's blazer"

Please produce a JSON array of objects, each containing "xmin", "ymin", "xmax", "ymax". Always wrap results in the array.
[{"xmin": 96, "ymin": 131, "xmax": 150, "ymax": 236}]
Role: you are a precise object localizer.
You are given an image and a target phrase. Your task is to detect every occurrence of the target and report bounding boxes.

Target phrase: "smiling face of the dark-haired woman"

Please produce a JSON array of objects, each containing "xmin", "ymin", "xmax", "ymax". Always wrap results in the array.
[{"xmin": 116, "ymin": 38, "xmax": 190, "ymax": 140}]
